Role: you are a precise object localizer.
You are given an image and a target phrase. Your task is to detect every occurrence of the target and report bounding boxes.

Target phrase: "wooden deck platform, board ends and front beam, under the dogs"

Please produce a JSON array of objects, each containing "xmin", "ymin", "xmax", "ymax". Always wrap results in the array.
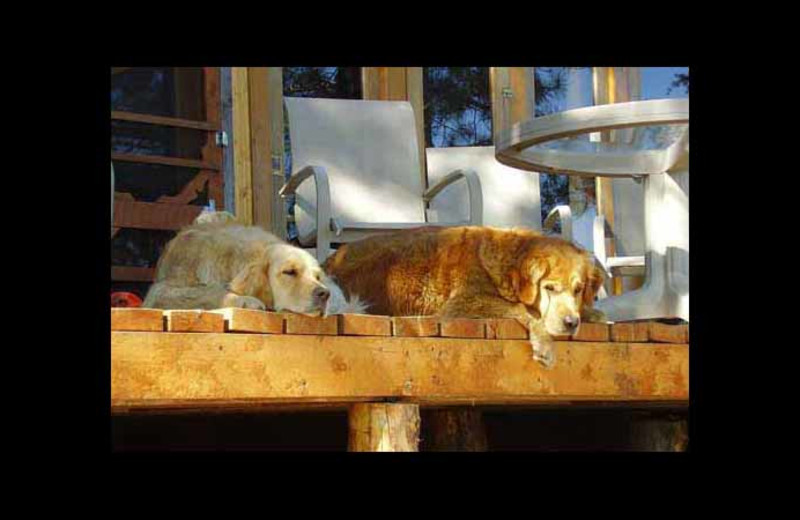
[{"xmin": 111, "ymin": 309, "xmax": 689, "ymax": 414}]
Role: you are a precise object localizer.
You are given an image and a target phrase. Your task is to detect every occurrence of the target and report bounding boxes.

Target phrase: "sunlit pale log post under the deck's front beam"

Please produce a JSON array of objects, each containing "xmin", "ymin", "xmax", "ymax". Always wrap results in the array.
[{"xmin": 348, "ymin": 403, "xmax": 419, "ymax": 451}]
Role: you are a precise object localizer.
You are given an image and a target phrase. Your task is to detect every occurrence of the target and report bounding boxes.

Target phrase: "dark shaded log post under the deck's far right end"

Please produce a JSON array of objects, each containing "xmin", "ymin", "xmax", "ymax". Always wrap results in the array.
[{"xmin": 630, "ymin": 413, "xmax": 689, "ymax": 452}]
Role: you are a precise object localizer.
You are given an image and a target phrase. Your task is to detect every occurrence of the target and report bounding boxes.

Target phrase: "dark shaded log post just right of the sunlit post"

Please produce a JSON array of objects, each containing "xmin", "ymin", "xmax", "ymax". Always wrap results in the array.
[{"xmin": 423, "ymin": 408, "xmax": 488, "ymax": 451}]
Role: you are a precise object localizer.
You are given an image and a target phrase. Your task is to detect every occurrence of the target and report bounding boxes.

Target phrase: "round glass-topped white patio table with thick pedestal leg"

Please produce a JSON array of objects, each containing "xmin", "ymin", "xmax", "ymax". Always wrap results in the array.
[{"xmin": 495, "ymin": 99, "xmax": 689, "ymax": 321}]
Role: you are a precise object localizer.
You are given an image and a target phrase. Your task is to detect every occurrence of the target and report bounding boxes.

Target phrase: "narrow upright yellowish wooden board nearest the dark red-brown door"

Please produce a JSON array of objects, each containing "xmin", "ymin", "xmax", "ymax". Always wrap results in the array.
[{"xmin": 231, "ymin": 67, "xmax": 253, "ymax": 226}]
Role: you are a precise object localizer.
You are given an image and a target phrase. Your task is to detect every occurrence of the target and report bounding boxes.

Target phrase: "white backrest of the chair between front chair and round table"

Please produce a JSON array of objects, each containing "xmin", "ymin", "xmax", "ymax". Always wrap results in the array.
[{"xmin": 425, "ymin": 146, "xmax": 542, "ymax": 230}]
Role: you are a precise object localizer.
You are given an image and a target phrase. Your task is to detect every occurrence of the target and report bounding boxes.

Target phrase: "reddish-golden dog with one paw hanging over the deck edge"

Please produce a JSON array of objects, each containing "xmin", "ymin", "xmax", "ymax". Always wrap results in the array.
[{"xmin": 323, "ymin": 227, "xmax": 604, "ymax": 366}]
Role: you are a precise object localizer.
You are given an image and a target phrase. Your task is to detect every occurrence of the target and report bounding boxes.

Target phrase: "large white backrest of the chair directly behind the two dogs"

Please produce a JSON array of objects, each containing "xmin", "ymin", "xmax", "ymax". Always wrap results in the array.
[{"xmin": 284, "ymin": 98, "xmax": 425, "ymax": 242}]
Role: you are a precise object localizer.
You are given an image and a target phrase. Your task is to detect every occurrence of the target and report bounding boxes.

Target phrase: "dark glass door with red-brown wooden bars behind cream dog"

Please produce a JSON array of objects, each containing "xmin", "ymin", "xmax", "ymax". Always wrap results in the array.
[{"xmin": 110, "ymin": 67, "xmax": 224, "ymax": 297}]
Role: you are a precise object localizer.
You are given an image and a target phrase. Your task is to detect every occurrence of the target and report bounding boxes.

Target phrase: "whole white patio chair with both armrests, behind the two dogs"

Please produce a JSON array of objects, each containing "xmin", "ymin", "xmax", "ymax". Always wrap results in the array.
[{"xmin": 280, "ymin": 98, "xmax": 483, "ymax": 262}]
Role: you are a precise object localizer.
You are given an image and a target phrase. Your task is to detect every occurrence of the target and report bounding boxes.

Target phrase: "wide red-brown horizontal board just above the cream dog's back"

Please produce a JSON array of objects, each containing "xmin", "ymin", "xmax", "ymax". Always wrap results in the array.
[{"xmin": 114, "ymin": 197, "xmax": 203, "ymax": 230}]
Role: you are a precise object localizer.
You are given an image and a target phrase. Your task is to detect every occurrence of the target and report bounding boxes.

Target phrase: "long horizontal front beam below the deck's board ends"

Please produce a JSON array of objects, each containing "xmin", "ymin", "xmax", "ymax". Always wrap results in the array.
[{"xmin": 111, "ymin": 331, "xmax": 689, "ymax": 408}]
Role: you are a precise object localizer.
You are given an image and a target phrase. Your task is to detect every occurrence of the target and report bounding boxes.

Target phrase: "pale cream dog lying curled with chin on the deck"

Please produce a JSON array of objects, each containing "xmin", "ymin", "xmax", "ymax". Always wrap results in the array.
[{"xmin": 143, "ymin": 212, "xmax": 365, "ymax": 315}]
